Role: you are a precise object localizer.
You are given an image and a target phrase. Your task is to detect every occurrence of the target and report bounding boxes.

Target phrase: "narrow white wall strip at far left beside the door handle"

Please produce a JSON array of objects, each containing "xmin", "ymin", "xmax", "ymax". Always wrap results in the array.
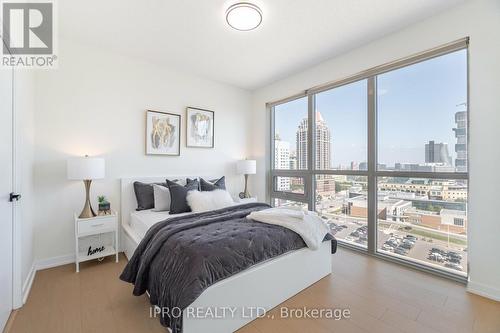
[{"xmin": 14, "ymin": 70, "xmax": 35, "ymax": 307}]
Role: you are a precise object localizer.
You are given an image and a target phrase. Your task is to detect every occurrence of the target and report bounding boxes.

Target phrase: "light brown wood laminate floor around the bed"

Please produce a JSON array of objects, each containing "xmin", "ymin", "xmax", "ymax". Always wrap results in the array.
[{"xmin": 7, "ymin": 249, "xmax": 500, "ymax": 333}]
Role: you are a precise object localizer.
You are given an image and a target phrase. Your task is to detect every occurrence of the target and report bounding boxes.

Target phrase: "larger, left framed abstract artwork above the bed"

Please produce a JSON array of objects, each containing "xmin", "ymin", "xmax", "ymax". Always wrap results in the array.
[{"xmin": 146, "ymin": 110, "xmax": 181, "ymax": 156}]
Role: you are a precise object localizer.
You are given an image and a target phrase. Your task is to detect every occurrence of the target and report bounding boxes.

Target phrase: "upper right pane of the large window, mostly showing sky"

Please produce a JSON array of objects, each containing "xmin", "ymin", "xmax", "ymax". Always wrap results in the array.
[{"xmin": 376, "ymin": 50, "xmax": 467, "ymax": 172}]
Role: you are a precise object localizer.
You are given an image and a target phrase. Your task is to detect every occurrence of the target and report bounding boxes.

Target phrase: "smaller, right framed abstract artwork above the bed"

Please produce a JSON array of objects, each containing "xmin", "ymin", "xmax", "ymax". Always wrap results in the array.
[{"xmin": 186, "ymin": 107, "xmax": 214, "ymax": 148}]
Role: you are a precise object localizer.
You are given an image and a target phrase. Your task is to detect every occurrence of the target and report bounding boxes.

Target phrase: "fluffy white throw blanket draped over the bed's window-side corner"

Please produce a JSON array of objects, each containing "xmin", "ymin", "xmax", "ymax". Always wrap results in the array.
[{"xmin": 247, "ymin": 208, "xmax": 330, "ymax": 250}]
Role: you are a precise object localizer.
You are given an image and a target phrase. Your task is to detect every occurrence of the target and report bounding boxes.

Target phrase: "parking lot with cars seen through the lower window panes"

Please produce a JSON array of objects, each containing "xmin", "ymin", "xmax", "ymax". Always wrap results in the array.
[{"xmin": 328, "ymin": 216, "xmax": 467, "ymax": 275}]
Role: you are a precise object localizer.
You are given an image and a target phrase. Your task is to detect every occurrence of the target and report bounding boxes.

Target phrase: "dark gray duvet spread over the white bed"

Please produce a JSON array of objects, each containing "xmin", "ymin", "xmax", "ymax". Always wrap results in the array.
[{"xmin": 120, "ymin": 203, "xmax": 336, "ymax": 333}]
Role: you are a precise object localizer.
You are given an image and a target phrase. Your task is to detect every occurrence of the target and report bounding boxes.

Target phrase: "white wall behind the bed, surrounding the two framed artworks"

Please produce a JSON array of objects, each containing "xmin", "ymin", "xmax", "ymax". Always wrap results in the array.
[{"xmin": 35, "ymin": 40, "xmax": 251, "ymax": 260}]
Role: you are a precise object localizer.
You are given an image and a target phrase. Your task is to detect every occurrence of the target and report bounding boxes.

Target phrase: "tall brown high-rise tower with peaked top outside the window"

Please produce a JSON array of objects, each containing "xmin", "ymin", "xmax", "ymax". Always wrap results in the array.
[{"xmin": 296, "ymin": 112, "xmax": 335, "ymax": 195}]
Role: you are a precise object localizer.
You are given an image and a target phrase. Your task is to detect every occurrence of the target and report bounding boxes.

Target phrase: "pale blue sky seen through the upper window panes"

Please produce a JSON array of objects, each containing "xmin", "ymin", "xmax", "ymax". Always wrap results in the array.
[{"xmin": 275, "ymin": 50, "xmax": 467, "ymax": 167}]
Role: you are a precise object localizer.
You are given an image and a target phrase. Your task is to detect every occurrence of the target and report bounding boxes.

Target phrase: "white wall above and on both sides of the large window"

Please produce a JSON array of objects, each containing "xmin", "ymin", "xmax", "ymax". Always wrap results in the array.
[{"xmin": 251, "ymin": 0, "xmax": 500, "ymax": 300}]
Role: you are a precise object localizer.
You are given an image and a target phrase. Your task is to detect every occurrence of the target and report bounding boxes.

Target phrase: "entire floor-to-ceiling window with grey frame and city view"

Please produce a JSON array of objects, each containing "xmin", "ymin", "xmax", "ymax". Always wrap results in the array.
[{"xmin": 270, "ymin": 39, "xmax": 468, "ymax": 276}]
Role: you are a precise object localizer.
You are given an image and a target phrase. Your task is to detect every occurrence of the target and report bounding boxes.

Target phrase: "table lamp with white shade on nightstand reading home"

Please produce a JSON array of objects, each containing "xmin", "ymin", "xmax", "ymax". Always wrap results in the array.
[{"xmin": 67, "ymin": 155, "xmax": 105, "ymax": 218}]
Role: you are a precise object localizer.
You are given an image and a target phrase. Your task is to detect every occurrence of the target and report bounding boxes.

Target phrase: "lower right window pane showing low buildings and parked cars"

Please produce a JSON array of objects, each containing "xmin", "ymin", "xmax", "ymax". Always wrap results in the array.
[{"xmin": 377, "ymin": 177, "xmax": 467, "ymax": 273}]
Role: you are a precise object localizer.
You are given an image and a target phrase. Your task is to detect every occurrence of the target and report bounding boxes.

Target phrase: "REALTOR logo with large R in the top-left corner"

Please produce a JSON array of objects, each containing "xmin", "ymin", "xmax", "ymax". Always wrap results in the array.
[{"xmin": 2, "ymin": 0, "xmax": 57, "ymax": 68}]
